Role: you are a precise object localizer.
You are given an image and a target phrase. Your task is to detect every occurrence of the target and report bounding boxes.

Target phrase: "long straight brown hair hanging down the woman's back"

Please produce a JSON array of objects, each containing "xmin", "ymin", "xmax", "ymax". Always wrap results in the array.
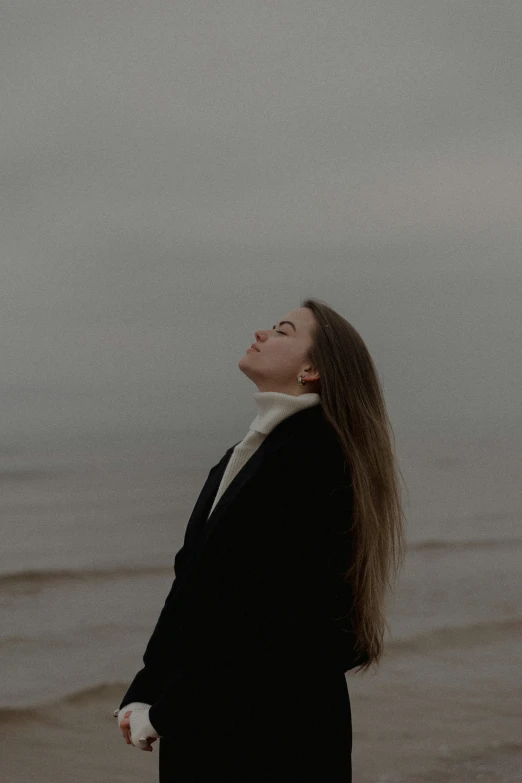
[{"xmin": 301, "ymin": 298, "xmax": 406, "ymax": 671}]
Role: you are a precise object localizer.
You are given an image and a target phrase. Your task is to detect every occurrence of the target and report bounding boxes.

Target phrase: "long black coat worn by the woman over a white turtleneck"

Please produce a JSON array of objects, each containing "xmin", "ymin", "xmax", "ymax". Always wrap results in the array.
[{"xmin": 120, "ymin": 405, "xmax": 365, "ymax": 783}]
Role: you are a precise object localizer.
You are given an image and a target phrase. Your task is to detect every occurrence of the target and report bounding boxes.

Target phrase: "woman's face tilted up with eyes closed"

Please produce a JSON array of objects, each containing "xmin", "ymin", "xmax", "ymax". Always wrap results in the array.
[{"xmin": 238, "ymin": 307, "xmax": 319, "ymax": 396}]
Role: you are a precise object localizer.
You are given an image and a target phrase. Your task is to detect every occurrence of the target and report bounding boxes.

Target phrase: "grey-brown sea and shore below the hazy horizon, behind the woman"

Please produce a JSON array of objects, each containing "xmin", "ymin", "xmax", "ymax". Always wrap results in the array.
[{"xmin": 0, "ymin": 438, "xmax": 522, "ymax": 783}]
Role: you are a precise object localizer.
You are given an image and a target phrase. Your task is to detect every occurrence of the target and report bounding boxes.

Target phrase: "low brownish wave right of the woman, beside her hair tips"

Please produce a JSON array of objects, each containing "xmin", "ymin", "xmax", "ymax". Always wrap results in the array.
[{"xmin": 385, "ymin": 617, "xmax": 522, "ymax": 653}]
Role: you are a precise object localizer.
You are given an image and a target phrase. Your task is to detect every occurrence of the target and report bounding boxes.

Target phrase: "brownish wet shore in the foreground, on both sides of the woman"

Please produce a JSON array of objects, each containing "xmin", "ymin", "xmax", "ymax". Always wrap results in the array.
[{"xmin": 1, "ymin": 624, "xmax": 522, "ymax": 783}]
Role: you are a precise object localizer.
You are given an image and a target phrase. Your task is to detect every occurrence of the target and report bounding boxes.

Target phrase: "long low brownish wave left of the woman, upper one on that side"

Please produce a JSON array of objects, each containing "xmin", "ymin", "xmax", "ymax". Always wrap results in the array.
[{"xmin": 0, "ymin": 566, "xmax": 174, "ymax": 589}]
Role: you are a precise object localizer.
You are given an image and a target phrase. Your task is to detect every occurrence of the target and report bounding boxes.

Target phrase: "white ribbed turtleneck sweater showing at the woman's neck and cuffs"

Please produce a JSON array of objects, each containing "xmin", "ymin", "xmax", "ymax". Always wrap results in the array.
[{"xmin": 115, "ymin": 392, "xmax": 321, "ymax": 745}]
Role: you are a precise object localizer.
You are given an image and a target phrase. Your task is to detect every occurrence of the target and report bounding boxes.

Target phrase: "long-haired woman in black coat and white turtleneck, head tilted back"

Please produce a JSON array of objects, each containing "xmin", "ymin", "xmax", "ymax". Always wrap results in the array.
[{"xmin": 115, "ymin": 299, "xmax": 404, "ymax": 783}]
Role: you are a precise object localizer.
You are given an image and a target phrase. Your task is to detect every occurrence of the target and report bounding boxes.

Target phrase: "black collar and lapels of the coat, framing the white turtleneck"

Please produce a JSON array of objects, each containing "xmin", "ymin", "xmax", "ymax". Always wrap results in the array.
[{"xmin": 185, "ymin": 405, "xmax": 333, "ymax": 549}]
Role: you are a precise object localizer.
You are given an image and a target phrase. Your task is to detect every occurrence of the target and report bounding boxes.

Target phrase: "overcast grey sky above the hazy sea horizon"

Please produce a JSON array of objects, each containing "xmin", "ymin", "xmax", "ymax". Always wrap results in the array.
[{"xmin": 0, "ymin": 0, "xmax": 522, "ymax": 447}]
